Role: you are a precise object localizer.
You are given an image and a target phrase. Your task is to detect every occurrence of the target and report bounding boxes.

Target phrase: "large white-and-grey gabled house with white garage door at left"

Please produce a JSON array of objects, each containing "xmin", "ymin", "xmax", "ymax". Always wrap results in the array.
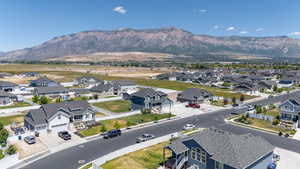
[{"xmin": 24, "ymin": 101, "xmax": 95, "ymax": 132}]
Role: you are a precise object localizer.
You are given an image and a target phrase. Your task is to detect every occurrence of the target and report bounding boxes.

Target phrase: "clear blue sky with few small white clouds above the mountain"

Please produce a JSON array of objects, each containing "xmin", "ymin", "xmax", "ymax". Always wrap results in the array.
[{"xmin": 0, "ymin": 0, "xmax": 300, "ymax": 52}]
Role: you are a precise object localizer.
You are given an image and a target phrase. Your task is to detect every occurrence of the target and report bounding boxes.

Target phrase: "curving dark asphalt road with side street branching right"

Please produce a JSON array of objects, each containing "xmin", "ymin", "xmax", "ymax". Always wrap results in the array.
[{"xmin": 23, "ymin": 92, "xmax": 300, "ymax": 169}]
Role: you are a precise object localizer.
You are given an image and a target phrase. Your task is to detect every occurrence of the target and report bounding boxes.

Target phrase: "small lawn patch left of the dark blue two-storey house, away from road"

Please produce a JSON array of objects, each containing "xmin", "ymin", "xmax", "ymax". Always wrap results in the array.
[{"xmin": 93, "ymin": 100, "xmax": 131, "ymax": 113}]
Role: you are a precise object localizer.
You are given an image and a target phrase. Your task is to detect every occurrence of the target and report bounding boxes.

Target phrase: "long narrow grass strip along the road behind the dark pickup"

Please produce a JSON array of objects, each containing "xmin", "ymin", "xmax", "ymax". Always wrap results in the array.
[{"xmin": 79, "ymin": 113, "xmax": 174, "ymax": 137}]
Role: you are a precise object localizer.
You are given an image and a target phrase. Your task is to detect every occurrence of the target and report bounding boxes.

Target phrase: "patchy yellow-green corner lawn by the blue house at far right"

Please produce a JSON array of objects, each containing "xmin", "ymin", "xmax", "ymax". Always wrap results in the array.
[{"xmin": 235, "ymin": 118, "xmax": 295, "ymax": 135}]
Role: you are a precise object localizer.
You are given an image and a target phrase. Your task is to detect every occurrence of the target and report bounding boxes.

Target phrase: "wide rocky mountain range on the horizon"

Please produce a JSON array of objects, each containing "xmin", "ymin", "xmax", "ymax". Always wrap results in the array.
[{"xmin": 0, "ymin": 27, "xmax": 300, "ymax": 60}]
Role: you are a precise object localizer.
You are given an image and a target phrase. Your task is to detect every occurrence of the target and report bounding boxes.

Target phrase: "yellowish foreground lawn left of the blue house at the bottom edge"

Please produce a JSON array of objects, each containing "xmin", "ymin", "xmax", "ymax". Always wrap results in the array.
[{"xmin": 101, "ymin": 141, "xmax": 171, "ymax": 169}]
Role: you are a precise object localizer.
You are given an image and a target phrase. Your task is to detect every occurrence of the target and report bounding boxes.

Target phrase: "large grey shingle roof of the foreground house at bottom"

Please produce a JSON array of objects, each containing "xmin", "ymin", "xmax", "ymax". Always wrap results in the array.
[{"xmin": 169, "ymin": 128, "xmax": 274, "ymax": 169}]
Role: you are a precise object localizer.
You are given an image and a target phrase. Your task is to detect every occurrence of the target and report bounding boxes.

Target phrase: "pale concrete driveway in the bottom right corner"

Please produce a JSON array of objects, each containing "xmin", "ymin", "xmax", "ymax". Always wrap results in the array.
[{"xmin": 274, "ymin": 148, "xmax": 300, "ymax": 169}]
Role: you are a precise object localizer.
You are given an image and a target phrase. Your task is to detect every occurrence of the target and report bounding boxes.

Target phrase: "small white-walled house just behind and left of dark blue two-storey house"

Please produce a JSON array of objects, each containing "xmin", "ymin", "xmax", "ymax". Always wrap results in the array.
[{"xmin": 111, "ymin": 80, "xmax": 137, "ymax": 95}]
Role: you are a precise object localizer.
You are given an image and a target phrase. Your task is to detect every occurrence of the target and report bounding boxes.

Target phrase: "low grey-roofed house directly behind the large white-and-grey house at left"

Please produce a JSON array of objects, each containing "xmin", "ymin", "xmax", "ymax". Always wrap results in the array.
[{"xmin": 34, "ymin": 86, "xmax": 70, "ymax": 100}]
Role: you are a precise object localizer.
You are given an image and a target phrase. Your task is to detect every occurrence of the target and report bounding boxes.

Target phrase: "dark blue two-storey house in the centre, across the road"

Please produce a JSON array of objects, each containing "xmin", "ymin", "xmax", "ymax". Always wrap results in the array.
[{"xmin": 127, "ymin": 88, "xmax": 172, "ymax": 110}]
